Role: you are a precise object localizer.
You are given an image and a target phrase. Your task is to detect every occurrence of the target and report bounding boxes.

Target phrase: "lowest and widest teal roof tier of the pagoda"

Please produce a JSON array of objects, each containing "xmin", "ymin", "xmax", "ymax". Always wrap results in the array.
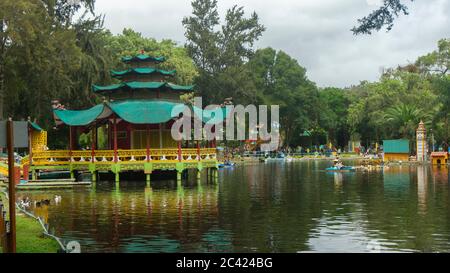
[{"xmin": 53, "ymin": 100, "xmax": 230, "ymax": 126}]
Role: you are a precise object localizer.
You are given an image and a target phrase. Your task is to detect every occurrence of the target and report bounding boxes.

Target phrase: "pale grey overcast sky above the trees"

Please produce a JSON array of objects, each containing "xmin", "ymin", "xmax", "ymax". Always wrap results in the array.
[{"xmin": 96, "ymin": 0, "xmax": 450, "ymax": 87}]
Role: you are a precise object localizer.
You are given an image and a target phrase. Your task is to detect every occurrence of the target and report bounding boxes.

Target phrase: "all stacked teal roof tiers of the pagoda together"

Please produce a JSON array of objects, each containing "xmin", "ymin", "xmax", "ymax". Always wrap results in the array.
[{"xmin": 53, "ymin": 54, "xmax": 227, "ymax": 126}]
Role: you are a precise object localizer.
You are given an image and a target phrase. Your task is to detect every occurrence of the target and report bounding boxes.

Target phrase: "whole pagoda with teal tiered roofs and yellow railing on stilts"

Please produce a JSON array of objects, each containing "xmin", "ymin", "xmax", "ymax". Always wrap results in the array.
[{"xmin": 23, "ymin": 53, "xmax": 223, "ymax": 181}]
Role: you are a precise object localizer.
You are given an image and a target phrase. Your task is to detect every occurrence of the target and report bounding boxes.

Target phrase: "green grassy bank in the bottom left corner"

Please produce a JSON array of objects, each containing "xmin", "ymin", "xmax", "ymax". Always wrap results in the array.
[{"xmin": 0, "ymin": 190, "xmax": 59, "ymax": 253}]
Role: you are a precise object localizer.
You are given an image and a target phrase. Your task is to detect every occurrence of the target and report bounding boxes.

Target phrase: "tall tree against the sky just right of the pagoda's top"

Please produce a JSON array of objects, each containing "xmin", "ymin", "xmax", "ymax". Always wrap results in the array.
[{"xmin": 183, "ymin": 0, "xmax": 265, "ymax": 103}]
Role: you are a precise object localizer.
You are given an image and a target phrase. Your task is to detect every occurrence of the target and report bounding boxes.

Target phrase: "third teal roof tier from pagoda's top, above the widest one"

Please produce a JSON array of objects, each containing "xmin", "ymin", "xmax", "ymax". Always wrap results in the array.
[{"xmin": 92, "ymin": 82, "xmax": 194, "ymax": 93}]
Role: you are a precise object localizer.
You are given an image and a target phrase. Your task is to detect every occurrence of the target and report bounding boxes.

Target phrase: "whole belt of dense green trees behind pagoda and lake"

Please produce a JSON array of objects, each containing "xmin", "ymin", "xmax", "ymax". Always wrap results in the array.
[{"xmin": 0, "ymin": 0, "xmax": 450, "ymax": 148}]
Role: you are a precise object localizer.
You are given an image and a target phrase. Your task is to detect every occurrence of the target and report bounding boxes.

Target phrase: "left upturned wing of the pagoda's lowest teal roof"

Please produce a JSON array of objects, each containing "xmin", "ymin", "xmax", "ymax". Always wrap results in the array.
[{"xmin": 53, "ymin": 104, "xmax": 105, "ymax": 126}]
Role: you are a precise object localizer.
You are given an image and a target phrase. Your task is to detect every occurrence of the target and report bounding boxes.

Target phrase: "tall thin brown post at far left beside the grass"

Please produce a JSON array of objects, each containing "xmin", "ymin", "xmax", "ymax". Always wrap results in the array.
[{"xmin": 6, "ymin": 118, "xmax": 16, "ymax": 253}]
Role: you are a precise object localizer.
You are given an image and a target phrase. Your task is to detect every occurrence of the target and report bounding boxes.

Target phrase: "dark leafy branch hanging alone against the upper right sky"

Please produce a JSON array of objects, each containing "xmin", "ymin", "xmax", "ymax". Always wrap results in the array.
[{"xmin": 352, "ymin": 0, "xmax": 414, "ymax": 35}]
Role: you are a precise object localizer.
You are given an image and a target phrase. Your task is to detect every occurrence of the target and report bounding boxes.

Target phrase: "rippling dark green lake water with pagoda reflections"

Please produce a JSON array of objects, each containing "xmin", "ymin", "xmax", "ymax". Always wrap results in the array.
[{"xmin": 19, "ymin": 161, "xmax": 450, "ymax": 252}]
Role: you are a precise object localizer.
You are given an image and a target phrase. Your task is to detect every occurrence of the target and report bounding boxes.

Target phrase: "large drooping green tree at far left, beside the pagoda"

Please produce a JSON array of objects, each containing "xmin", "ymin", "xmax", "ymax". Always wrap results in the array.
[{"xmin": 0, "ymin": 0, "xmax": 100, "ymax": 121}]
